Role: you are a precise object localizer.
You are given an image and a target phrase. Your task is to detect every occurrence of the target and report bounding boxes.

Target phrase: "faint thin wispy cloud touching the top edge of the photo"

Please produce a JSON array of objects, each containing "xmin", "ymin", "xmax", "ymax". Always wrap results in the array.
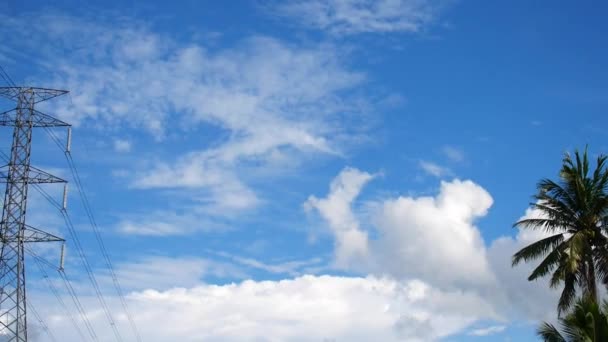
[{"xmin": 270, "ymin": 0, "xmax": 442, "ymax": 35}]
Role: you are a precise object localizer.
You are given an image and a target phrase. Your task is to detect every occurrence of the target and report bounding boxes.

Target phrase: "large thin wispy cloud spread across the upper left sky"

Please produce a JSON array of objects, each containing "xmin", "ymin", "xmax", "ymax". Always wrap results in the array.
[{"xmin": 0, "ymin": 14, "xmax": 370, "ymax": 214}]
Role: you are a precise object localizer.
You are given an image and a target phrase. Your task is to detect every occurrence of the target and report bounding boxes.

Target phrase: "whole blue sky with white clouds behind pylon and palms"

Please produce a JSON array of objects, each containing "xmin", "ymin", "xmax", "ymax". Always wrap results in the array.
[{"xmin": 0, "ymin": 0, "xmax": 608, "ymax": 341}]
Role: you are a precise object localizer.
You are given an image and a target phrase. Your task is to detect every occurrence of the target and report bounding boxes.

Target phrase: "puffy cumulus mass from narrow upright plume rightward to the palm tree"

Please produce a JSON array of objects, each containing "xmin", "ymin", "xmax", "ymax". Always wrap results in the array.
[{"xmin": 307, "ymin": 168, "xmax": 559, "ymax": 333}]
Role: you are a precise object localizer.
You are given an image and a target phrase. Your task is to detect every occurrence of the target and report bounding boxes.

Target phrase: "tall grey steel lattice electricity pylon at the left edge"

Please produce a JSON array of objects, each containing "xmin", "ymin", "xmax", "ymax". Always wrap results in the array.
[{"xmin": 0, "ymin": 87, "xmax": 69, "ymax": 342}]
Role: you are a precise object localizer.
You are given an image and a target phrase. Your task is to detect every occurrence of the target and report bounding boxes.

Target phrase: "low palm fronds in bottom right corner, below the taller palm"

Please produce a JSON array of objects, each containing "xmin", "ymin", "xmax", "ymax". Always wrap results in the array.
[{"xmin": 536, "ymin": 297, "xmax": 608, "ymax": 342}]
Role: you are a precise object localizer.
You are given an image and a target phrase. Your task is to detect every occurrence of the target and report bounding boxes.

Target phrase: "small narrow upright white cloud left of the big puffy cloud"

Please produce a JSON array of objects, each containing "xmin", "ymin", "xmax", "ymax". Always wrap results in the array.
[{"xmin": 304, "ymin": 168, "xmax": 374, "ymax": 267}]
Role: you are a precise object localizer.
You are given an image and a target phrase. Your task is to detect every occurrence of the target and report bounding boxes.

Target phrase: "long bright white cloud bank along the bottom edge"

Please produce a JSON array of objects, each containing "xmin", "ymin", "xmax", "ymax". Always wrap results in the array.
[{"xmin": 35, "ymin": 276, "xmax": 494, "ymax": 342}]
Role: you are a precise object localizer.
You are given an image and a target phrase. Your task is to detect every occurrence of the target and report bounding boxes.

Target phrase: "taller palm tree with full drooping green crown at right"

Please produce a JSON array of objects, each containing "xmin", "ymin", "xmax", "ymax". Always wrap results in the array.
[{"xmin": 513, "ymin": 148, "xmax": 608, "ymax": 314}]
